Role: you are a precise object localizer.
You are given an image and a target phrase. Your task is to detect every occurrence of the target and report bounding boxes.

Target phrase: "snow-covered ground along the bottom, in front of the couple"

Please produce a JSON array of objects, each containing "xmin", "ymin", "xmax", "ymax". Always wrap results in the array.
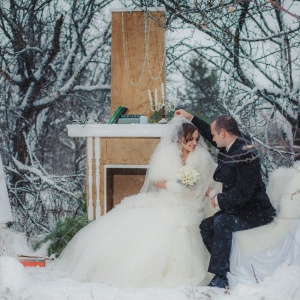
[{"xmin": 0, "ymin": 229, "xmax": 300, "ymax": 300}]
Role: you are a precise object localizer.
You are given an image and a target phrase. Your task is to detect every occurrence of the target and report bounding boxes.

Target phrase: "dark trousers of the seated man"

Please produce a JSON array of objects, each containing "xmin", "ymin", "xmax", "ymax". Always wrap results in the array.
[{"xmin": 200, "ymin": 213, "xmax": 256, "ymax": 276}]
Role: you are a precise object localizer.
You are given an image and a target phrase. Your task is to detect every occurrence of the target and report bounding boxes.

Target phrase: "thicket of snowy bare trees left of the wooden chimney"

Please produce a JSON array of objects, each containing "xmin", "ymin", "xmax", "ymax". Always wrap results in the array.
[{"xmin": 0, "ymin": 0, "xmax": 112, "ymax": 237}]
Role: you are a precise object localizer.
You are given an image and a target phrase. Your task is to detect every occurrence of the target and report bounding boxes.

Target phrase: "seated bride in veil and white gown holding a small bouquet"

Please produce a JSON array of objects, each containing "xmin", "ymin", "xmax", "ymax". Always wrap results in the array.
[{"xmin": 58, "ymin": 117, "xmax": 219, "ymax": 287}]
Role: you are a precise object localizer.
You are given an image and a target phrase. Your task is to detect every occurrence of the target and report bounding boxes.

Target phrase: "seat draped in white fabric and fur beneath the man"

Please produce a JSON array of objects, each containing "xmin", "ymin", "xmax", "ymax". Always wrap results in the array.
[{"xmin": 228, "ymin": 163, "xmax": 300, "ymax": 287}]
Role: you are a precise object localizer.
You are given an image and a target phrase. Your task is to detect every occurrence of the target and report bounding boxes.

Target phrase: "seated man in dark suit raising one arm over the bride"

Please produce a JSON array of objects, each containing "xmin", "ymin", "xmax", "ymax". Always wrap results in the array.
[{"xmin": 175, "ymin": 109, "xmax": 276, "ymax": 288}]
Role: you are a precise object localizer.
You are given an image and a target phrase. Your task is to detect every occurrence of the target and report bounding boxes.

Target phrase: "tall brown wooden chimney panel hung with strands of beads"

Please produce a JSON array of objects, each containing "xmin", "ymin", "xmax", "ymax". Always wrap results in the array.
[{"xmin": 111, "ymin": 11, "xmax": 166, "ymax": 116}]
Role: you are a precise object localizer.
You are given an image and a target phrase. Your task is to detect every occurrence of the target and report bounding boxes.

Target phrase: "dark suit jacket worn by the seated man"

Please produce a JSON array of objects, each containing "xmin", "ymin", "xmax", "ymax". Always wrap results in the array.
[{"xmin": 192, "ymin": 116, "xmax": 276, "ymax": 227}]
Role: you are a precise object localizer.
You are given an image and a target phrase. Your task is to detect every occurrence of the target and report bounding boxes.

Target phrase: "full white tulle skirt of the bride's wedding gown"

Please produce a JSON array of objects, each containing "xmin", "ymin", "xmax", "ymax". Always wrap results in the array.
[{"xmin": 58, "ymin": 191, "xmax": 210, "ymax": 287}]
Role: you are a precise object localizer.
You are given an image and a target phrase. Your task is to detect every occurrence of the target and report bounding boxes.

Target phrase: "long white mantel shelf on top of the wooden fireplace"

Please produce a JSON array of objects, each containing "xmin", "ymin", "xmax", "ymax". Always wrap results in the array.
[{"xmin": 67, "ymin": 124, "xmax": 171, "ymax": 138}]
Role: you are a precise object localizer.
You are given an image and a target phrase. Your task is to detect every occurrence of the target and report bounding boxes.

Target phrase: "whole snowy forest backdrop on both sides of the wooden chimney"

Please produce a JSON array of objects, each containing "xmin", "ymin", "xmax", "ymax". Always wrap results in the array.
[{"xmin": 0, "ymin": 0, "xmax": 300, "ymax": 248}]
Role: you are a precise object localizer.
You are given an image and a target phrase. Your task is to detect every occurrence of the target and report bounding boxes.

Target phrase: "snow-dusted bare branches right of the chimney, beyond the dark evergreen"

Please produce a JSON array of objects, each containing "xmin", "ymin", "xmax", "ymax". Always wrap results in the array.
[{"xmin": 126, "ymin": 0, "xmax": 300, "ymax": 169}]
